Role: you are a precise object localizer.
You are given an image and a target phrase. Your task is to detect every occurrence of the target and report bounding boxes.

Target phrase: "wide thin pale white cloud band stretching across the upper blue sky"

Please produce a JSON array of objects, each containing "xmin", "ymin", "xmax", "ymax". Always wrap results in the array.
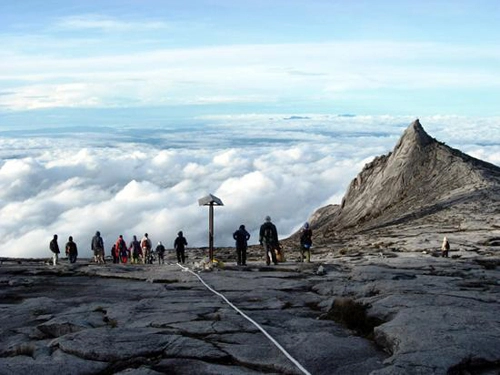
[{"xmin": 0, "ymin": 41, "xmax": 500, "ymax": 110}]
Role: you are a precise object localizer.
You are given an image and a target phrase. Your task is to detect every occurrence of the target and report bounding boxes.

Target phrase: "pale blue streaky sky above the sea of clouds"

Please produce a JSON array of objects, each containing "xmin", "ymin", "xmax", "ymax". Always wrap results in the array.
[{"xmin": 0, "ymin": 0, "xmax": 500, "ymax": 128}]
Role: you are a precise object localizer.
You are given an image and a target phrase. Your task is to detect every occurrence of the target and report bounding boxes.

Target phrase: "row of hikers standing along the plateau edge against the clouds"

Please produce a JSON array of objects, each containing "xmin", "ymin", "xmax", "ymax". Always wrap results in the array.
[{"xmin": 49, "ymin": 216, "xmax": 312, "ymax": 266}]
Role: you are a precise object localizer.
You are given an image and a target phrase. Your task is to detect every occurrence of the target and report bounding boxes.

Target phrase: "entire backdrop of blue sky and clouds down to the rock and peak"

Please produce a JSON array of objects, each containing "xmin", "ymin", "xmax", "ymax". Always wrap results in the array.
[{"xmin": 0, "ymin": 0, "xmax": 500, "ymax": 256}]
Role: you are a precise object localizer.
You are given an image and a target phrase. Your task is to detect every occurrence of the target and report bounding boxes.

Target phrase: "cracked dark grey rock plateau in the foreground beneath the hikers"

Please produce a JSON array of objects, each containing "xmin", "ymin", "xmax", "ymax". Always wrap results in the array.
[{"xmin": 0, "ymin": 249, "xmax": 500, "ymax": 375}]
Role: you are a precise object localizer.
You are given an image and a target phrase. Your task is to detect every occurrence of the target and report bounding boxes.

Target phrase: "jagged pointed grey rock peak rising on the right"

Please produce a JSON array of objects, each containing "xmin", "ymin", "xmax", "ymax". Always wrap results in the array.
[{"xmin": 311, "ymin": 120, "xmax": 500, "ymax": 245}]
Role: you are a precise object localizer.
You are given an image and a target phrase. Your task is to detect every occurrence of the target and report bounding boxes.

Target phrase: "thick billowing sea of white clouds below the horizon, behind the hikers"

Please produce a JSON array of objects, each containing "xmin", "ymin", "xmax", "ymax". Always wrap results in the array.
[{"xmin": 0, "ymin": 115, "xmax": 500, "ymax": 257}]
